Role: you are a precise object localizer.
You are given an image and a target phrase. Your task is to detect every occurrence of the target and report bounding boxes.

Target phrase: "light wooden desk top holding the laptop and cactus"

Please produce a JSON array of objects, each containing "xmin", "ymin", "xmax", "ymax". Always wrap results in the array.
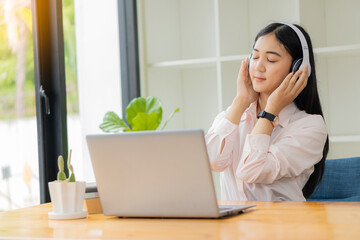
[{"xmin": 0, "ymin": 202, "xmax": 360, "ymax": 240}]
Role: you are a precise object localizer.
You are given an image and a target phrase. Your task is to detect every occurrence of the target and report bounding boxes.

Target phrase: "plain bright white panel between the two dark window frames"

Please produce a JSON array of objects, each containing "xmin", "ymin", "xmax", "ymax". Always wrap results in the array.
[{"xmin": 73, "ymin": 0, "xmax": 121, "ymax": 181}]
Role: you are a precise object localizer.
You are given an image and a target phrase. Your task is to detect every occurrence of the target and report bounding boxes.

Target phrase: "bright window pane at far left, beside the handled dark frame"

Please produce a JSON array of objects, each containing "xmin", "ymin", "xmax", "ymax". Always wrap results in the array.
[{"xmin": 0, "ymin": 0, "xmax": 40, "ymax": 211}]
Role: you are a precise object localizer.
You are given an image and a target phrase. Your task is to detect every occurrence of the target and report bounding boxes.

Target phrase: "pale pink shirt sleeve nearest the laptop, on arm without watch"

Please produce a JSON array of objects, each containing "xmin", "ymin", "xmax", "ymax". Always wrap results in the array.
[{"xmin": 205, "ymin": 112, "xmax": 239, "ymax": 172}]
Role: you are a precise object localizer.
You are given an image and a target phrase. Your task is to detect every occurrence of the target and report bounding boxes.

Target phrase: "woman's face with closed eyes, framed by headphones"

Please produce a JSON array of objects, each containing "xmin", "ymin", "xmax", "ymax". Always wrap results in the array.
[{"xmin": 249, "ymin": 33, "xmax": 292, "ymax": 95}]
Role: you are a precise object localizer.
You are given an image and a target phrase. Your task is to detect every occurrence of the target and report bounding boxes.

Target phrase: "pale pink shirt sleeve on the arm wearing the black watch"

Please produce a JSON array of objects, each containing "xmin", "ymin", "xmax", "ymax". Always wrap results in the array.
[{"xmin": 236, "ymin": 115, "xmax": 327, "ymax": 184}]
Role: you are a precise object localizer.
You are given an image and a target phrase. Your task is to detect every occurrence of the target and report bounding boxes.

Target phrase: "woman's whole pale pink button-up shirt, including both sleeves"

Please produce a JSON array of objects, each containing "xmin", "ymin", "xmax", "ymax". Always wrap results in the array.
[{"xmin": 205, "ymin": 102, "xmax": 327, "ymax": 201}]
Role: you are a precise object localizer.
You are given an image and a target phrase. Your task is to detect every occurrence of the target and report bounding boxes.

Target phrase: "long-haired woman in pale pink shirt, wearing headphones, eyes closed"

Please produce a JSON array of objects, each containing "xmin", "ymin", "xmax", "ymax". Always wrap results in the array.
[{"xmin": 206, "ymin": 23, "xmax": 329, "ymax": 201}]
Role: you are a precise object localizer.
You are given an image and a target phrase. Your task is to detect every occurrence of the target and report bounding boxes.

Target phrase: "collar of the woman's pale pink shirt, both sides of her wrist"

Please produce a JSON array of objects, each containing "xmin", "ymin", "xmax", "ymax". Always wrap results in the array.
[{"xmin": 241, "ymin": 101, "xmax": 298, "ymax": 127}]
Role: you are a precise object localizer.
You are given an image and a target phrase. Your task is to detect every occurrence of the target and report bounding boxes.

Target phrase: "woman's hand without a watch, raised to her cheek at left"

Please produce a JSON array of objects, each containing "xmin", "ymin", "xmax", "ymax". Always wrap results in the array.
[{"xmin": 236, "ymin": 58, "xmax": 259, "ymax": 106}]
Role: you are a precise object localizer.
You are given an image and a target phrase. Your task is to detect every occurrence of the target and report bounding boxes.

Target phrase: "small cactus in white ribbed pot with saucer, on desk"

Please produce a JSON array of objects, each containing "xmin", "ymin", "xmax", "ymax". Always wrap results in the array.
[{"xmin": 48, "ymin": 150, "xmax": 87, "ymax": 219}]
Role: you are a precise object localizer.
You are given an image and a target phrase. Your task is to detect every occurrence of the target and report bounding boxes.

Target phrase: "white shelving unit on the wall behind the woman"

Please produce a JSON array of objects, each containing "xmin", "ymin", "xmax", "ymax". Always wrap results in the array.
[{"xmin": 138, "ymin": 0, "xmax": 360, "ymax": 158}]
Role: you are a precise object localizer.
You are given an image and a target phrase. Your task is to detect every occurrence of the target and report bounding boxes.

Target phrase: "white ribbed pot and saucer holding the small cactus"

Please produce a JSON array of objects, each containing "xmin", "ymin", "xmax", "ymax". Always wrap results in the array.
[{"xmin": 48, "ymin": 181, "xmax": 87, "ymax": 219}]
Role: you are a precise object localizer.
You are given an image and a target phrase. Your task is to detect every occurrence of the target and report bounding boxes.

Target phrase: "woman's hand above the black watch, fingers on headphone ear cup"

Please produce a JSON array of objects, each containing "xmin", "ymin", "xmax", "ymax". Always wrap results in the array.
[{"xmin": 265, "ymin": 65, "xmax": 308, "ymax": 116}]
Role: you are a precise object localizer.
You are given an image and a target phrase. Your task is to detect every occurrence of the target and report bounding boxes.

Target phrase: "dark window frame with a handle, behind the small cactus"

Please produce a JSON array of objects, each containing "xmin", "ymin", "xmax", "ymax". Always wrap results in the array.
[{"xmin": 31, "ymin": 0, "xmax": 68, "ymax": 203}]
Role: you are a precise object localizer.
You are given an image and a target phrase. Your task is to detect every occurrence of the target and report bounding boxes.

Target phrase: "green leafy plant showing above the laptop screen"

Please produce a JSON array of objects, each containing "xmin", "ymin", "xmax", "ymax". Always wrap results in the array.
[{"xmin": 100, "ymin": 97, "xmax": 180, "ymax": 133}]
